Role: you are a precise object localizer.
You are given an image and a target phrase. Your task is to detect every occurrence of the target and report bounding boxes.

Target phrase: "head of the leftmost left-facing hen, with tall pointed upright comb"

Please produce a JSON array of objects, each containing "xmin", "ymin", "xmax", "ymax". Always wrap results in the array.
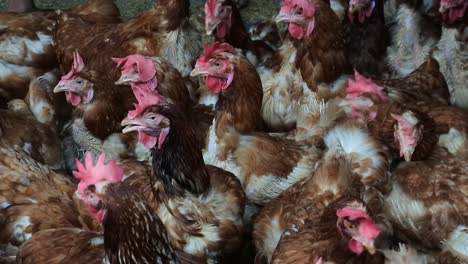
[{"xmin": 54, "ymin": 50, "xmax": 94, "ymax": 106}]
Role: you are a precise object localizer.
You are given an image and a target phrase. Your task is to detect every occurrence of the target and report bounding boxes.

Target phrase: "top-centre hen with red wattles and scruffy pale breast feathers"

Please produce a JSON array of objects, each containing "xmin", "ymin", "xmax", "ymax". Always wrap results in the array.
[{"xmin": 259, "ymin": 0, "xmax": 350, "ymax": 132}]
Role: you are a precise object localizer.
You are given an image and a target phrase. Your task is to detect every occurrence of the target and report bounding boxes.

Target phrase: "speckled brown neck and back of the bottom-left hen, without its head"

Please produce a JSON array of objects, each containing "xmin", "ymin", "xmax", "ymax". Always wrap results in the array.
[{"xmin": 17, "ymin": 184, "xmax": 197, "ymax": 264}]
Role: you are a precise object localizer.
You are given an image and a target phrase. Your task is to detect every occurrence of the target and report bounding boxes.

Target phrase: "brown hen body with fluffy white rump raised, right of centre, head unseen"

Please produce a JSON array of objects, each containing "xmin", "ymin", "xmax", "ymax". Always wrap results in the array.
[{"xmin": 253, "ymin": 123, "xmax": 388, "ymax": 263}]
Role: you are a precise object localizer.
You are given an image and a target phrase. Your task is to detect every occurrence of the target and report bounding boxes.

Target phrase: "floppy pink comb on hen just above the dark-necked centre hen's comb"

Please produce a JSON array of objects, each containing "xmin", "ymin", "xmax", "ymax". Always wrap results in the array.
[{"xmin": 112, "ymin": 54, "xmax": 156, "ymax": 82}]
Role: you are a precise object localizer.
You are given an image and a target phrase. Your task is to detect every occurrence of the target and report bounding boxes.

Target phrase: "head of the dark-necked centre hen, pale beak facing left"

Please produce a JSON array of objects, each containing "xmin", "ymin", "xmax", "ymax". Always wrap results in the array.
[{"xmin": 121, "ymin": 86, "xmax": 170, "ymax": 149}]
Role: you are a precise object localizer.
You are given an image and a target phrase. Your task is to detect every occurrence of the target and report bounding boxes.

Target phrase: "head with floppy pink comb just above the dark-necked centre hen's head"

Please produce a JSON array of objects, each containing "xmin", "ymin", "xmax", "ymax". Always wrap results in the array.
[{"xmin": 112, "ymin": 54, "xmax": 158, "ymax": 90}]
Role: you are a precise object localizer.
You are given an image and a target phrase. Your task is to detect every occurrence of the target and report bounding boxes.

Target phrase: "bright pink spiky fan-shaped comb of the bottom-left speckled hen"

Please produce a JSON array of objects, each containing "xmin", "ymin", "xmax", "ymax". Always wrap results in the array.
[{"xmin": 73, "ymin": 152, "xmax": 124, "ymax": 193}]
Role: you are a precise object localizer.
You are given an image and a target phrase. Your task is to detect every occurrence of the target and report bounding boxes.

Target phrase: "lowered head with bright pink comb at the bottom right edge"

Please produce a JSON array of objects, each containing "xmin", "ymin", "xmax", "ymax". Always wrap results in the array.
[{"xmin": 336, "ymin": 204, "xmax": 380, "ymax": 255}]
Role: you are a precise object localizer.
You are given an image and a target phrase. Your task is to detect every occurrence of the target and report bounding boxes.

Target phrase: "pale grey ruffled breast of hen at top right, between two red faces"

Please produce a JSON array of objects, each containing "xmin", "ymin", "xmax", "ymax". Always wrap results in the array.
[{"xmin": 386, "ymin": 0, "xmax": 440, "ymax": 78}]
